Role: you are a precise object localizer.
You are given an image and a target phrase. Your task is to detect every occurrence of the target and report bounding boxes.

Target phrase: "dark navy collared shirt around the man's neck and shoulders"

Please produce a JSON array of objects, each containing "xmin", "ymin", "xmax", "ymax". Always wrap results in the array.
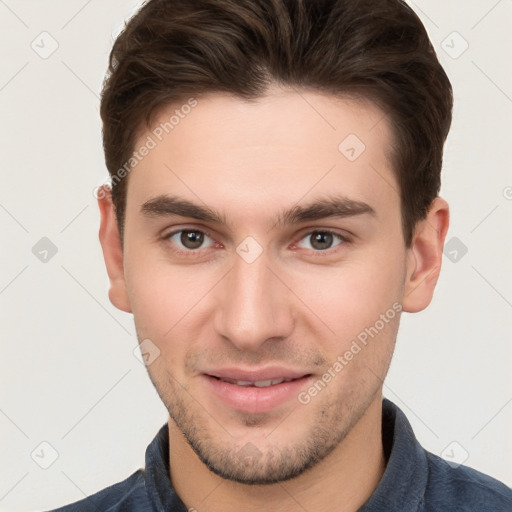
[{"xmin": 48, "ymin": 399, "xmax": 512, "ymax": 512}]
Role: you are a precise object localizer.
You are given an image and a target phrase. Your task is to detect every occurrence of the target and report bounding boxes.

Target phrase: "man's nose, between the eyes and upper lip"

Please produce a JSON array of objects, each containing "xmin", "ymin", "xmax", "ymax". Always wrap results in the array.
[{"xmin": 214, "ymin": 245, "xmax": 294, "ymax": 351}]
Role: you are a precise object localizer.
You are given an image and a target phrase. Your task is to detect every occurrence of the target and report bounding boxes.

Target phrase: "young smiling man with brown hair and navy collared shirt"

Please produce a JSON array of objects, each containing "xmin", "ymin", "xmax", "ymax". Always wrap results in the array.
[{"xmin": 50, "ymin": 0, "xmax": 512, "ymax": 512}]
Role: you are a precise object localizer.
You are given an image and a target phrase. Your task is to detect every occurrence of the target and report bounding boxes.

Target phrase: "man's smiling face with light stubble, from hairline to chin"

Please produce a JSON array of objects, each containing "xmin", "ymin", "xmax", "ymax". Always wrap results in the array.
[{"xmin": 114, "ymin": 89, "xmax": 407, "ymax": 483}]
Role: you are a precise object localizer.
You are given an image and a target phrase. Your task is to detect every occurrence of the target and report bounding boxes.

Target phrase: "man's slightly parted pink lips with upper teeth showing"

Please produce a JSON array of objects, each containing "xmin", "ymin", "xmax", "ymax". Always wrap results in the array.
[{"xmin": 201, "ymin": 369, "xmax": 314, "ymax": 414}]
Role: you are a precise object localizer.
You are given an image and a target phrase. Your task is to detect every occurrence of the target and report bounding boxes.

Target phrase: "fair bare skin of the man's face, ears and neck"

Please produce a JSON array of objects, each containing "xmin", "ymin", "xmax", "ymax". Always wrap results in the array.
[{"xmin": 98, "ymin": 87, "xmax": 449, "ymax": 512}]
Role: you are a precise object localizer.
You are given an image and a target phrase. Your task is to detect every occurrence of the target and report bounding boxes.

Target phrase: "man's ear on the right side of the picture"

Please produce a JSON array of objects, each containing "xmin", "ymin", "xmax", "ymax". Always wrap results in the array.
[{"xmin": 402, "ymin": 197, "xmax": 450, "ymax": 313}]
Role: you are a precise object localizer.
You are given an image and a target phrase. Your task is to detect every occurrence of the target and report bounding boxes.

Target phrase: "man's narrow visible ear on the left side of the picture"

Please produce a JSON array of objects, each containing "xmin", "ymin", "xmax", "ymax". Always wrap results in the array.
[{"xmin": 97, "ymin": 185, "xmax": 132, "ymax": 313}]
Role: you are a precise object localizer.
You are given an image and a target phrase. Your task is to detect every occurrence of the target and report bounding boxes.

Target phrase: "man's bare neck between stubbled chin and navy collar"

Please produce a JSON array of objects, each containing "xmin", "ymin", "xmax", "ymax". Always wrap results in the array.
[{"xmin": 169, "ymin": 393, "xmax": 386, "ymax": 512}]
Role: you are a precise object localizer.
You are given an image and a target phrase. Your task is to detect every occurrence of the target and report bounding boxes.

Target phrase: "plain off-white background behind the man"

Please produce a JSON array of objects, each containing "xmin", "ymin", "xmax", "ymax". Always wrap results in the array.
[{"xmin": 0, "ymin": 0, "xmax": 512, "ymax": 512}]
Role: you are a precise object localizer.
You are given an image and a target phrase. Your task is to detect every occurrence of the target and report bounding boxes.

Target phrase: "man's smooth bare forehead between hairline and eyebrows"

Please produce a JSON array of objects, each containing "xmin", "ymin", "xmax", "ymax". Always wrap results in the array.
[{"xmin": 127, "ymin": 88, "xmax": 399, "ymax": 226}]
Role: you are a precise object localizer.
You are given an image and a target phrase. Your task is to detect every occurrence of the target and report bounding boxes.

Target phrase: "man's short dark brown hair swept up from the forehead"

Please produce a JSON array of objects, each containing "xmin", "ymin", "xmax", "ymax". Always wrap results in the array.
[{"xmin": 101, "ymin": 0, "xmax": 453, "ymax": 247}]
